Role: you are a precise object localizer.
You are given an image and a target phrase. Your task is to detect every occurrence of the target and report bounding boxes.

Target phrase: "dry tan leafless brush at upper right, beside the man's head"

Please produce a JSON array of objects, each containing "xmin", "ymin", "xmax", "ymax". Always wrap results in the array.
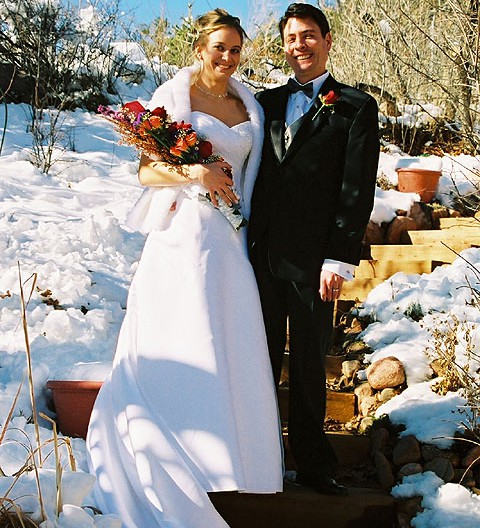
[{"xmin": 329, "ymin": 0, "xmax": 480, "ymax": 152}]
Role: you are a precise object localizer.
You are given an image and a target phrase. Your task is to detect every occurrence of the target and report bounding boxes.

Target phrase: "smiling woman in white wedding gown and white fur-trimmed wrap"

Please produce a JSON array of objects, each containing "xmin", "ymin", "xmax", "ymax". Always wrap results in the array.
[{"xmin": 87, "ymin": 9, "xmax": 283, "ymax": 528}]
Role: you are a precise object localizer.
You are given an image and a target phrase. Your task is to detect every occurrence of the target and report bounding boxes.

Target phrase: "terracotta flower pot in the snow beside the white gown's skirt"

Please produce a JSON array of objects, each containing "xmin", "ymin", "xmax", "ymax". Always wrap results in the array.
[{"xmin": 47, "ymin": 380, "xmax": 103, "ymax": 438}]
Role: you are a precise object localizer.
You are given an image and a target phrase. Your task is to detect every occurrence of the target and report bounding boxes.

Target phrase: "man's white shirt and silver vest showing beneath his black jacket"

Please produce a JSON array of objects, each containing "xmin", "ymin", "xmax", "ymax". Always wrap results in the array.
[{"xmin": 285, "ymin": 71, "xmax": 355, "ymax": 280}]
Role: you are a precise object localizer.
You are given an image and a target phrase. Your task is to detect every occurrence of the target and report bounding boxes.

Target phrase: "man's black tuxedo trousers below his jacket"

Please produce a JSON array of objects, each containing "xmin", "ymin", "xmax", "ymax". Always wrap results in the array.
[{"xmin": 251, "ymin": 245, "xmax": 337, "ymax": 478}]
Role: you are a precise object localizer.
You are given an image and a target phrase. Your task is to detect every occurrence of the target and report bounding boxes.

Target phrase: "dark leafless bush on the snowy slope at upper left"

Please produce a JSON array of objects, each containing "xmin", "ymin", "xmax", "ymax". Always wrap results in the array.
[{"xmin": 0, "ymin": 0, "xmax": 141, "ymax": 173}]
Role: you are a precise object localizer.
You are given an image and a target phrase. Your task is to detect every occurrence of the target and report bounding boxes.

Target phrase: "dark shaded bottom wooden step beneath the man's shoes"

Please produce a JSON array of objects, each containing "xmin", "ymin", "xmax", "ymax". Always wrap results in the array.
[{"xmin": 210, "ymin": 484, "xmax": 397, "ymax": 528}]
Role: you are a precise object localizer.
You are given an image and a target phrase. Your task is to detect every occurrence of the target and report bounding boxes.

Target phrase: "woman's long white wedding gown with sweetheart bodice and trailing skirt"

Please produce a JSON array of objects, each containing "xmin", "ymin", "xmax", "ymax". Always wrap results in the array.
[{"xmin": 87, "ymin": 112, "xmax": 283, "ymax": 528}]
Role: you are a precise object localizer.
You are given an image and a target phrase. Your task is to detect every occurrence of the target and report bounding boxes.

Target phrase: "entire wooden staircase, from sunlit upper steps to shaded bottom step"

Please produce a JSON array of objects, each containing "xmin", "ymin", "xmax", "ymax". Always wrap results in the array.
[{"xmin": 215, "ymin": 218, "xmax": 480, "ymax": 528}]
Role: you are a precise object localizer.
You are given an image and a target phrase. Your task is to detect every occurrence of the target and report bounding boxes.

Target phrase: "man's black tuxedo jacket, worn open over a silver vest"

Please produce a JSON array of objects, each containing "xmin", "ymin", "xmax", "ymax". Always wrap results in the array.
[{"xmin": 248, "ymin": 75, "xmax": 379, "ymax": 287}]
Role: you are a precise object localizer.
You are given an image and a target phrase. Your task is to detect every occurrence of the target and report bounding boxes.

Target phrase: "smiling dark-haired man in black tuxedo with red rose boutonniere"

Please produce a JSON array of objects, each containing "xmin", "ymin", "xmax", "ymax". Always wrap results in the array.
[{"xmin": 248, "ymin": 3, "xmax": 379, "ymax": 495}]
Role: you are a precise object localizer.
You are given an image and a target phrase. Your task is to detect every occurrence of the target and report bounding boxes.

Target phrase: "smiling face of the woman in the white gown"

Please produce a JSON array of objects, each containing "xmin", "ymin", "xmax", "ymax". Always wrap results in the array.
[{"xmin": 197, "ymin": 27, "xmax": 242, "ymax": 82}]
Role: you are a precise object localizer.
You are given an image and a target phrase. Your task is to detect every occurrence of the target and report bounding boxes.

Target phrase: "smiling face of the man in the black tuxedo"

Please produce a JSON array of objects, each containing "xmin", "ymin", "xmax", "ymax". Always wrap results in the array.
[{"xmin": 283, "ymin": 18, "xmax": 332, "ymax": 83}]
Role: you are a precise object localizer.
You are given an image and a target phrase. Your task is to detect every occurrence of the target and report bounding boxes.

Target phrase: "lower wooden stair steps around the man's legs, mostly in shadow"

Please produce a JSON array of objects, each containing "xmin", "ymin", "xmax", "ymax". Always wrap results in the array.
[{"xmin": 210, "ymin": 372, "xmax": 397, "ymax": 528}]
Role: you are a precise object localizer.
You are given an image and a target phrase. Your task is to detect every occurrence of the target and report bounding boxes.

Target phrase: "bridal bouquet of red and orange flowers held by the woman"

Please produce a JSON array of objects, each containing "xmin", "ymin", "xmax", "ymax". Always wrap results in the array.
[{"xmin": 98, "ymin": 101, "xmax": 247, "ymax": 230}]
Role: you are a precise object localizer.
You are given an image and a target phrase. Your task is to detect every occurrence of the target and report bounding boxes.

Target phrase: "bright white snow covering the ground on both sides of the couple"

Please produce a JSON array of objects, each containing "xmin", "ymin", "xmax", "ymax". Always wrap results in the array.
[{"xmin": 0, "ymin": 50, "xmax": 480, "ymax": 528}]
